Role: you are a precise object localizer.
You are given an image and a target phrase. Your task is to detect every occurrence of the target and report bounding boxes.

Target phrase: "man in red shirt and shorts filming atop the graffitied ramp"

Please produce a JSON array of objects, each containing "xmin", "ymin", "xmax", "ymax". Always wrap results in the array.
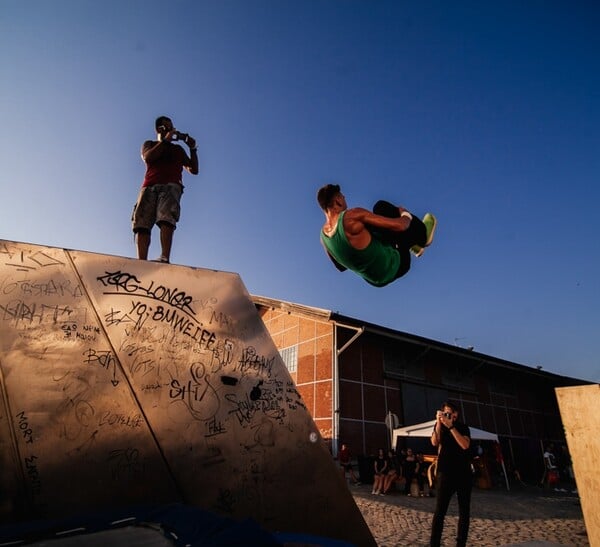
[{"xmin": 131, "ymin": 116, "xmax": 198, "ymax": 263}]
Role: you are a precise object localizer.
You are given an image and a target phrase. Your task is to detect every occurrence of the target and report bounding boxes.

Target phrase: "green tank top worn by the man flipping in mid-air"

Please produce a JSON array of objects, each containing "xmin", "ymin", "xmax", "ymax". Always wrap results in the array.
[{"xmin": 321, "ymin": 211, "xmax": 400, "ymax": 287}]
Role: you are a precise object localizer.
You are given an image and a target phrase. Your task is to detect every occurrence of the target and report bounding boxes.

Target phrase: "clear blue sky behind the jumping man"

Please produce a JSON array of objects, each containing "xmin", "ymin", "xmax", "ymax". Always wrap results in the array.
[{"xmin": 0, "ymin": 0, "xmax": 600, "ymax": 382}]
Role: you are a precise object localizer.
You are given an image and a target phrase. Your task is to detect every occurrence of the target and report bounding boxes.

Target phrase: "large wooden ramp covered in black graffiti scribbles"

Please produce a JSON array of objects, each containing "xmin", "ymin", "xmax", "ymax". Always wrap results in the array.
[{"xmin": 0, "ymin": 240, "xmax": 375, "ymax": 546}]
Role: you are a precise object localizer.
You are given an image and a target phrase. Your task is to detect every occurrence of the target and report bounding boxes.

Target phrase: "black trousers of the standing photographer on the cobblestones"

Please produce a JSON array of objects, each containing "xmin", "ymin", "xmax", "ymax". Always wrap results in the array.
[{"xmin": 429, "ymin": 471, "xmax": 473, "ymax": 547}]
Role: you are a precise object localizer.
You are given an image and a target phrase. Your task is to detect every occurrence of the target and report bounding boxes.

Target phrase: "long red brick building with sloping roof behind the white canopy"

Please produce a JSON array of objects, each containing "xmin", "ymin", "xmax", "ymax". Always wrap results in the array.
[{"xmin": 252, "ymin": 296, "xmax": 589, "ymax": 482}]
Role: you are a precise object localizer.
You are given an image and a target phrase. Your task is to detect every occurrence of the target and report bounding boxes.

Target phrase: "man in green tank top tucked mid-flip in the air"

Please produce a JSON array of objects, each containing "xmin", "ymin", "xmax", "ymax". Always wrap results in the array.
[{"xmin": 317, "ymin": 184, "xmax": 437, "ymax": 287}]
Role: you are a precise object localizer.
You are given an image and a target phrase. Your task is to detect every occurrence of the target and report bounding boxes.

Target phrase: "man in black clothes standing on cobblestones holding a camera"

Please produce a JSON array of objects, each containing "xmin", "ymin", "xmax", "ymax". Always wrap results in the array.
[{"xmin": 430, "ymin": 402, "xmax": 473, "ymax": 547}]
